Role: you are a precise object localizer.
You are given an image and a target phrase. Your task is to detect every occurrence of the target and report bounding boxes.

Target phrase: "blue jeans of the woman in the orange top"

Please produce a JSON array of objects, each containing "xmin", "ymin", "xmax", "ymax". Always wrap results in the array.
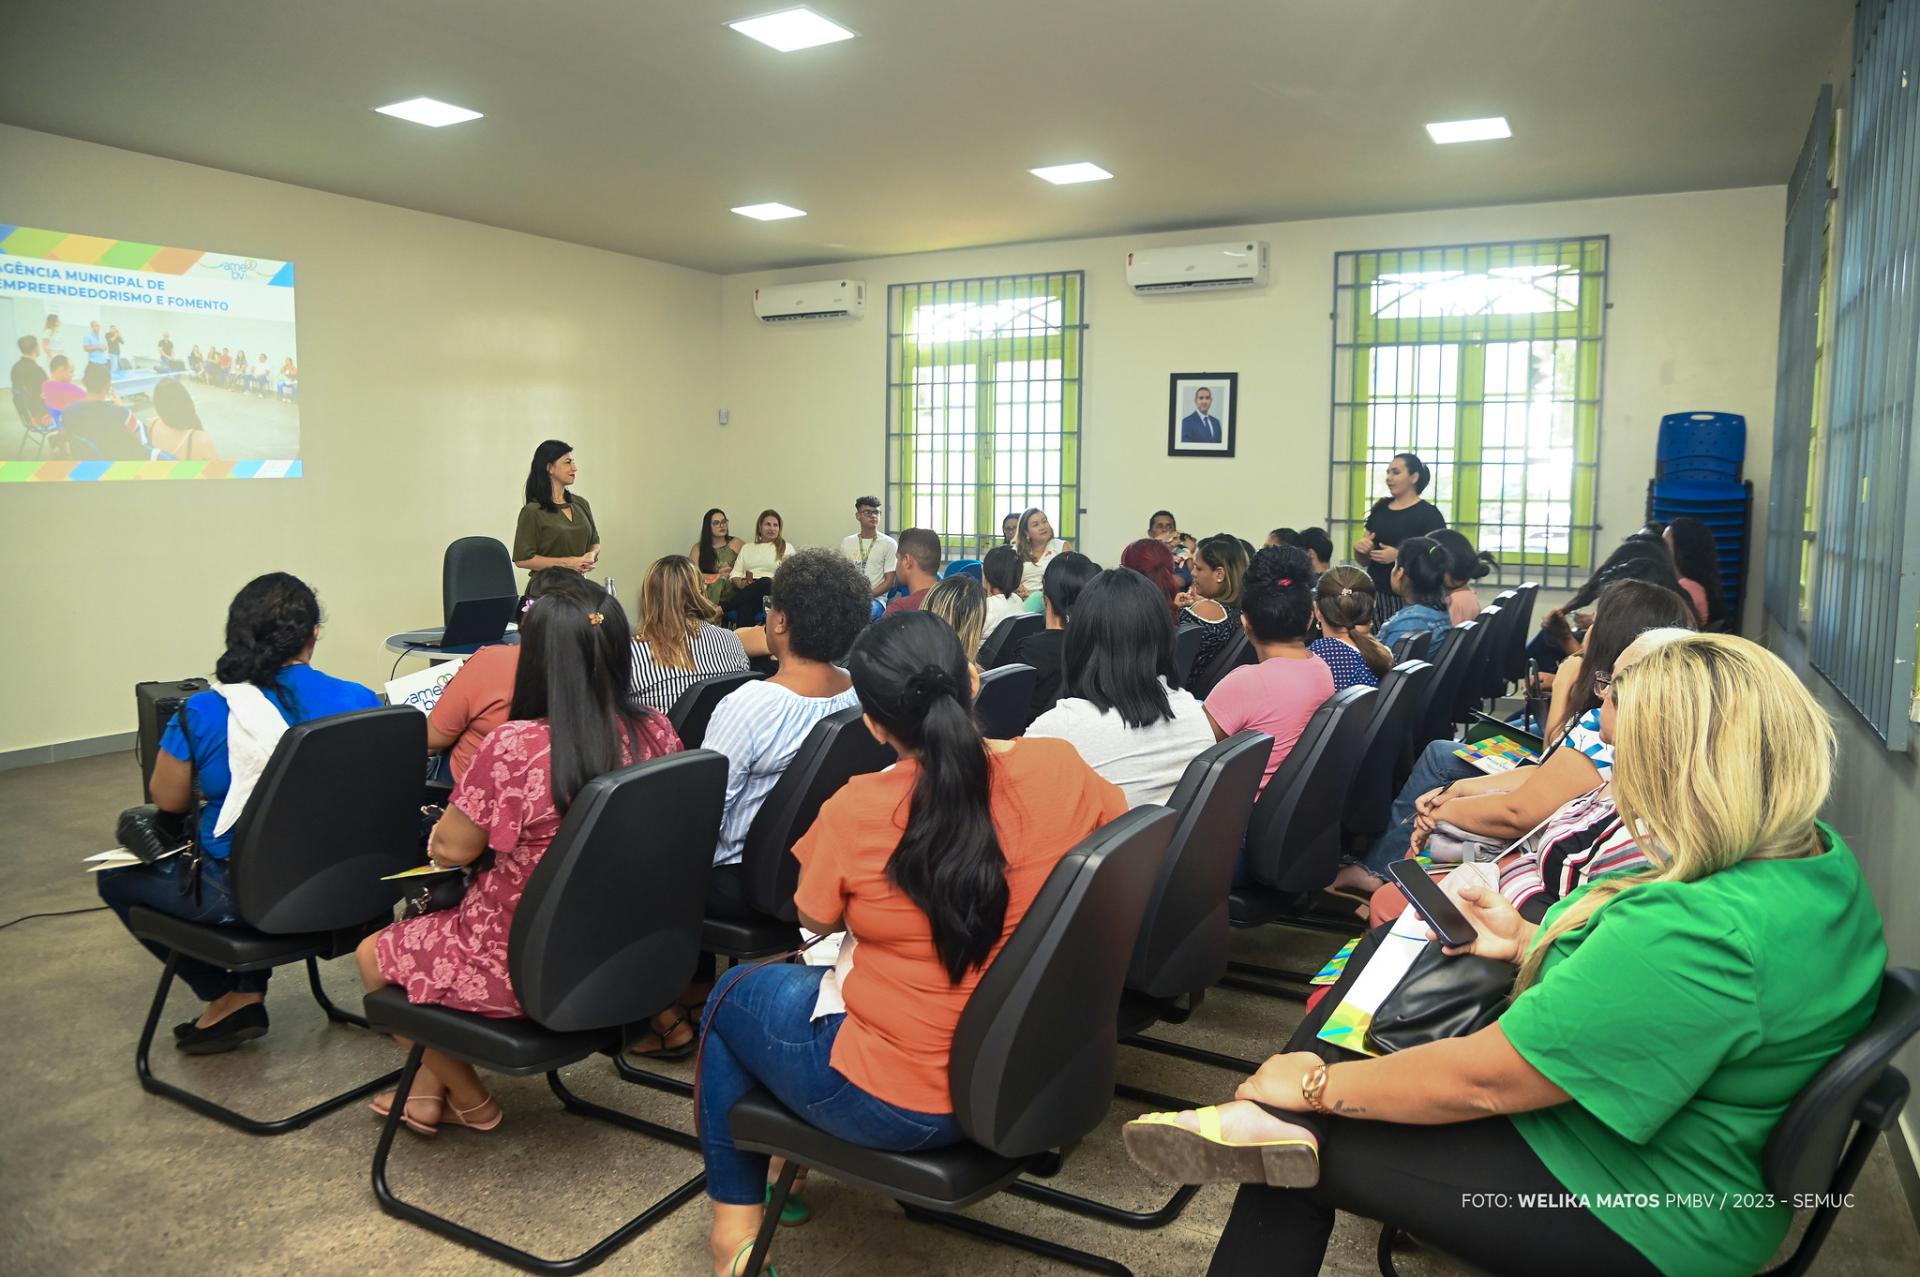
[{"xmin": 699, "ymin": 964, "xmax": 966, "ymax": 1206}]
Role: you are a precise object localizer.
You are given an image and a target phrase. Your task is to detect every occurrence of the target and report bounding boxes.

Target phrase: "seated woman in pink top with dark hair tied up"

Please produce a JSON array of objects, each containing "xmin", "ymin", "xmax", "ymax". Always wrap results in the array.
[{"xmin": 1206, "ymin": 545, "xmax": 1332, "ymax": 791}]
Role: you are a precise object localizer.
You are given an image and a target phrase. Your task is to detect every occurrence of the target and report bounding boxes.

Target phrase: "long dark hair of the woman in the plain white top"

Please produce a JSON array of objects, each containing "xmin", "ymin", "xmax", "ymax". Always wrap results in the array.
[{"xmin": 1062, "ymin": 568, "xmax": 1173, "ymax": 728}]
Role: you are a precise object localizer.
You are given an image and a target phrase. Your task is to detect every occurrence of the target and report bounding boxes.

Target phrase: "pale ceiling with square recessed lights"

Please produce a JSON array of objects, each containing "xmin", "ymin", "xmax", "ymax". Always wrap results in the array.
[{"xmin": 0, "ymin": 0, "xmax": 1853, "ymax": 273}]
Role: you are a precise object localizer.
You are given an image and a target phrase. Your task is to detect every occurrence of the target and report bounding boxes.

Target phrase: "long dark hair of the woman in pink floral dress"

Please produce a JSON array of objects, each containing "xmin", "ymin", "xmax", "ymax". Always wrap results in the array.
[{"xmin": 507, "ymin": 568, "xmax": 668, "ymax": 812}]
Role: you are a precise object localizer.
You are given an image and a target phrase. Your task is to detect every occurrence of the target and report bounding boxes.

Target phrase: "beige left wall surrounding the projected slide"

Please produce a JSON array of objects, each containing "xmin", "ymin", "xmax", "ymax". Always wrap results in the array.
[{"xmin": 0, "ymin": 127, "xmax": 720, "ymax": 755}]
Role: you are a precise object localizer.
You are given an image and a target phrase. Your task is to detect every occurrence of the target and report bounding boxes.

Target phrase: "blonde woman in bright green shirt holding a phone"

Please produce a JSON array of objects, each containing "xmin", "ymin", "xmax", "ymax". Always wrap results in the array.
[{"xmin": 1125, "ymin": 634, "xmax": 1887, "ymax": 1277}]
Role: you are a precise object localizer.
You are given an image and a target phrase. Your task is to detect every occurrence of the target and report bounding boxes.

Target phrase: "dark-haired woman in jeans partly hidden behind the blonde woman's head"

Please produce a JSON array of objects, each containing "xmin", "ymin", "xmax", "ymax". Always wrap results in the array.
[{"xmin": 1332, "ymin": 582, "xmax": 1693, "ymax": 895}]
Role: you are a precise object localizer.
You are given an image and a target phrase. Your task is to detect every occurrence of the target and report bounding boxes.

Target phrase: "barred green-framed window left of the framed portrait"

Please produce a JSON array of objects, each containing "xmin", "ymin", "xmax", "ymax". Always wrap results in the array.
[{"xmin": 887, "ymin": 271, "xmax": 1087, "ymax": 561}]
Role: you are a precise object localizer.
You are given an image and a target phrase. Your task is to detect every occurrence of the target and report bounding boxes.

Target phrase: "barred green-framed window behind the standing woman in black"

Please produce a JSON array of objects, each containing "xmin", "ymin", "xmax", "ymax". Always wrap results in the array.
[{"xmin": 1329, "ymin": 236, "xmax": 1609, "ymax": 588}]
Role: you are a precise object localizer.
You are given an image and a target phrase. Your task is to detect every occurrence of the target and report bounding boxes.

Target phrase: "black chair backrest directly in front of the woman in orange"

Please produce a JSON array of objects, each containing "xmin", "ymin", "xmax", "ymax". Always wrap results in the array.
[{"xmin": 733, "ymin": 705, "xmax": 895, "ymax": 922}]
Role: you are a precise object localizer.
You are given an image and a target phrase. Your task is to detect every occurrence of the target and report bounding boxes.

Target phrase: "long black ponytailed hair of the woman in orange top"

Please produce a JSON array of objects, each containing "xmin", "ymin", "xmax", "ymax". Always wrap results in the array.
[{"xmin": 847, "ymin": 613, "xmax": 1008, "ymax": 983}]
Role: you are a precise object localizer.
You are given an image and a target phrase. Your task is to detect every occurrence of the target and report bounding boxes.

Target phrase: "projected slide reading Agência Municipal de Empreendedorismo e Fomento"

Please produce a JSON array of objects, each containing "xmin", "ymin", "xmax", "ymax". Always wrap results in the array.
[{"xmin": 0, "ymin": 223, "xmax": 300, "ymax": 484}]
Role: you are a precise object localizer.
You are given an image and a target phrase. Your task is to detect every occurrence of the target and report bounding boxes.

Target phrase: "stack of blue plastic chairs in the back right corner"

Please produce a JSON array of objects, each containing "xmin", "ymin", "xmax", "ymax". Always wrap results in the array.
[{"xmin": 1647, "ymin": 413, "xmax": 1753, "ymax": 632}]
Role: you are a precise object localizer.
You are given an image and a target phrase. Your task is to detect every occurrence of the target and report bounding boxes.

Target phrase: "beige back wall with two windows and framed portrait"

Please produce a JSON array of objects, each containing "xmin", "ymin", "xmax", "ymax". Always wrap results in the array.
[{"xmin": 718, "ymin": 186, "xmax": 1784, "ymax": 622}]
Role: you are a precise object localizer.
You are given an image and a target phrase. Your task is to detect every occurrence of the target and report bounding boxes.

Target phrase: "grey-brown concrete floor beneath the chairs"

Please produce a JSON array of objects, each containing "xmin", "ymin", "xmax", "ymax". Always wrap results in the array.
[{"xmin": 0, "ymin": 755, "xmax": 1920, "ymax": 1277}]
